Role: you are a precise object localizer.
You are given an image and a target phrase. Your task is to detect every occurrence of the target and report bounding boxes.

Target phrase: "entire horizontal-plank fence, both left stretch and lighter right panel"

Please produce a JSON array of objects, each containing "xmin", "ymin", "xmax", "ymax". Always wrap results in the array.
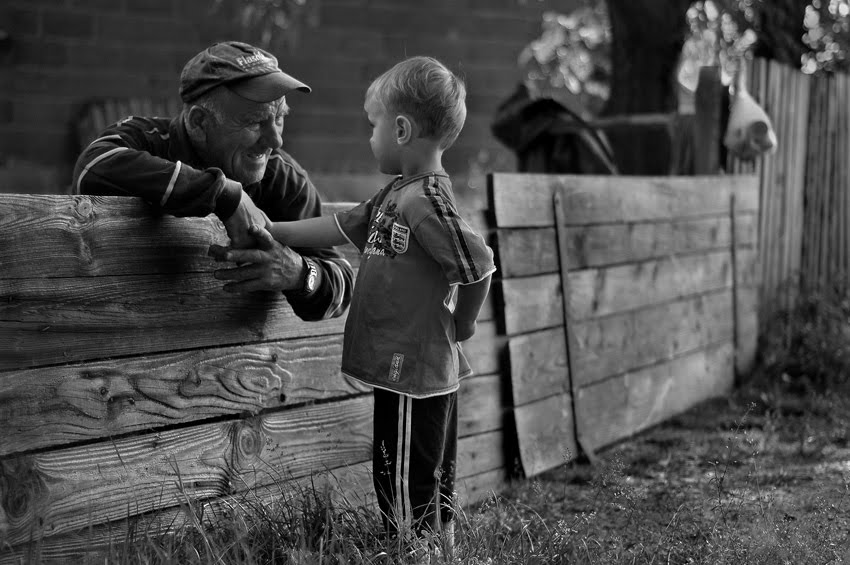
[{"xmin": 0, "ymin": 175, "xmax": 758, "ymax": 563}]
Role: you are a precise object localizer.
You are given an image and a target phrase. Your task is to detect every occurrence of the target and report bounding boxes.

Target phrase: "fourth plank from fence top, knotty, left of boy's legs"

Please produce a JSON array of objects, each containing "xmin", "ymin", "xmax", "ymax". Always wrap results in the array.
[{"xmin": 0, "ymin": 395, "xmax": 372, "ymax": 545}]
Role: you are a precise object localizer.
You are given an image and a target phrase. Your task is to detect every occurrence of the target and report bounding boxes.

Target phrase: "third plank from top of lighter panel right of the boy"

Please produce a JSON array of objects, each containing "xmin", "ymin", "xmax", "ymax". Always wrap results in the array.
[{"xmin": 500, "ymin": 248, "xmax": 756, "ymax": 335}]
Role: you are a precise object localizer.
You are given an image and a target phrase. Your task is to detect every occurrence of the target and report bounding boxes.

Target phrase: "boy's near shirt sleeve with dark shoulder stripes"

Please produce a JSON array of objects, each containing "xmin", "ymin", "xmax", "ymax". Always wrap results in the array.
[{"xmin": 413, "ymin": 205, "xmax": 496, "ymax": 284}]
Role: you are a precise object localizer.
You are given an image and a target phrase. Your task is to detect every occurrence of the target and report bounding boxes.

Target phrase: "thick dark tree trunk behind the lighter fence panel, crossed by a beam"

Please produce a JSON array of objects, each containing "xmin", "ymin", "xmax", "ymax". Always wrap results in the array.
[{"xmin": 604, "ymin": 0, "xmax": 691, "ymax": 175}]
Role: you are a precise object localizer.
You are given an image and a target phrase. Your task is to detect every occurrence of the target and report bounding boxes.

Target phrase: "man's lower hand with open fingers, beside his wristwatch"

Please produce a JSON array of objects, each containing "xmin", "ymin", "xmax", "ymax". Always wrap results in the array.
[{"xmin": 209, "ymin": 224, "xmax": 304, "ymax": 292}]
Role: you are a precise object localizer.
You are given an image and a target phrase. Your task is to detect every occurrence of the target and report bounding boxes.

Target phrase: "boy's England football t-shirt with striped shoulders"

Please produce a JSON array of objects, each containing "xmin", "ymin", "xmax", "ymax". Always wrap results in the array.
[{"xmin": 335, "ymin": 171, "xmax": 496, "ymax": 398}]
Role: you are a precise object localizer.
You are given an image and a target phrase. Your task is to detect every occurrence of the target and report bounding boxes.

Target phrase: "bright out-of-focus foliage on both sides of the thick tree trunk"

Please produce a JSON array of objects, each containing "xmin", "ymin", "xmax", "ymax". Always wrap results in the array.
[{"xmin": 519, "ymin": 0, "xmax": 850, "ymax": 106}]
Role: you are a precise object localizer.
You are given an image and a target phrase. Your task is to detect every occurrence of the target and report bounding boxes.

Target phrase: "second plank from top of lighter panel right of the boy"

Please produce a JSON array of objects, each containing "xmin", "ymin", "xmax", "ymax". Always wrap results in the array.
[{"xmin": 496, "ymin": 213, "xmax": 757, "ymax": 278}]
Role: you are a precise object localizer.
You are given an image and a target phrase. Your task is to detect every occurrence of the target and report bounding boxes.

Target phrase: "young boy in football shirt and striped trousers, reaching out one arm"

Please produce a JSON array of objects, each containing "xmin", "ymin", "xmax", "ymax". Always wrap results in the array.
[{"xmin": 269, "ymin": 57, "xmax": 495, "ymax": 543}]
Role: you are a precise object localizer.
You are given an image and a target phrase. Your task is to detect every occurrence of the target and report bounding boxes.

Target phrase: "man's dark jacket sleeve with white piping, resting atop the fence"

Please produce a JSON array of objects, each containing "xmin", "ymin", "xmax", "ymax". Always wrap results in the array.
[{"xmin": 73, "ymin": 118, "xmax": 241, "ymax": 219}]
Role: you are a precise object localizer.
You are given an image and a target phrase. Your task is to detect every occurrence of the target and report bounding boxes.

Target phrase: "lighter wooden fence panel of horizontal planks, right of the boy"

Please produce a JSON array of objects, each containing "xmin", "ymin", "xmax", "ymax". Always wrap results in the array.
[{"xmin": 491, "ymin": 174, "xmax": 758, "ymax": 475}]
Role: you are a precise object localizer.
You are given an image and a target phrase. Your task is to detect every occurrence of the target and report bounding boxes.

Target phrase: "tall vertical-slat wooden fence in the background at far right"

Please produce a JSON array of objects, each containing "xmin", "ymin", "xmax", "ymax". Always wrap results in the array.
[{"xmin": 729, "ymin": 59, "xmax": 850, "ymax": 306}]
